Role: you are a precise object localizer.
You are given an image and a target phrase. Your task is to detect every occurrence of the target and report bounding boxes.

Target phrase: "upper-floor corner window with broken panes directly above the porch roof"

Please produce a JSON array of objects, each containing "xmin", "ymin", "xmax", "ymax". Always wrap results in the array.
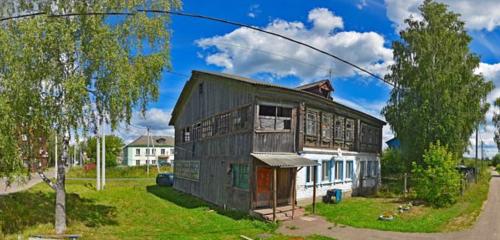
[{"xmin": 259, "ymin": 105, "xmax": 292, "ymax": 130}]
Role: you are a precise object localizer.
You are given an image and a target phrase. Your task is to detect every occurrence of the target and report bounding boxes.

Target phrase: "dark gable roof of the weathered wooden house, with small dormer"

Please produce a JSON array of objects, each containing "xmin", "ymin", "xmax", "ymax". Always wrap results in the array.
[{"xmin": 168, "ymin": 70, "xmax": 386, "ymax": 126}]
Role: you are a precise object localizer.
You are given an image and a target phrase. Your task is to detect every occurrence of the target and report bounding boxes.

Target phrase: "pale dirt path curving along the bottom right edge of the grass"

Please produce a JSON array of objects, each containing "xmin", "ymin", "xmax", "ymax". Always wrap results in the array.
[{"xmin": 278, "ymin": 172, "xmax": 500, "ymax": 240}]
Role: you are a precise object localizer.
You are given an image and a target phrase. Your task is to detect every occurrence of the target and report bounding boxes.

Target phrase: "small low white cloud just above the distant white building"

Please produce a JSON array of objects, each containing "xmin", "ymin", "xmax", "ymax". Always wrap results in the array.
[{"xmin": 115, "ymin": 108, "xmax": 174, "ymax": 144}]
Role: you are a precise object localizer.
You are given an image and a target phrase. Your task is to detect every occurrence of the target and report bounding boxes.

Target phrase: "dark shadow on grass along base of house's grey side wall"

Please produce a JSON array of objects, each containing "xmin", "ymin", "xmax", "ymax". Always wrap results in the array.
[{"xmin": 146, "ymin": 185, "xmax": 254, "ymax": 220}]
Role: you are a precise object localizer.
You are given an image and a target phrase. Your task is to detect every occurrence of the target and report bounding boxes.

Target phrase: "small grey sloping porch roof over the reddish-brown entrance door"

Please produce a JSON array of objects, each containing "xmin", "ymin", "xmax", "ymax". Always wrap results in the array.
[{"xmin": 251, "ymin": 153, "xmax": 319, "ymax": 168}]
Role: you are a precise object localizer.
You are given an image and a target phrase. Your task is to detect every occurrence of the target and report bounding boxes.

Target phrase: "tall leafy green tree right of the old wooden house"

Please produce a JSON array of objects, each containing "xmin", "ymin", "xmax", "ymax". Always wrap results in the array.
[{"xmin": 382, "ymin": 0, "xmax": 493, "ymax": 168}]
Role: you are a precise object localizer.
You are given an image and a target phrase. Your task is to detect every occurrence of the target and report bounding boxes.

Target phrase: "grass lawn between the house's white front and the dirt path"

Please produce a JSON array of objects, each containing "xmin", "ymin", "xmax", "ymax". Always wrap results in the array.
[{"xmin": 307, "ymin": 172, "xmax": 489, "ymax": 232}]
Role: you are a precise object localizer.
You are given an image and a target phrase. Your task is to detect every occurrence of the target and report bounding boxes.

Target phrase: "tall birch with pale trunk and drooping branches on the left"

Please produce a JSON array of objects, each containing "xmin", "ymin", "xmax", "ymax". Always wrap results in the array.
[{"xmin": 0, "ymin": 0, "xmax": 180, "ymax": 234}]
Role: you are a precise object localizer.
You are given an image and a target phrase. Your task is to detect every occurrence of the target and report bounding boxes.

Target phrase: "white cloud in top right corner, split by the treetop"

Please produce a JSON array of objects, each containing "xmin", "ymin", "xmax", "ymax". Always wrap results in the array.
[{"xmin": 385, "ymin": 0, "xmax": 500, "ymax": 31}]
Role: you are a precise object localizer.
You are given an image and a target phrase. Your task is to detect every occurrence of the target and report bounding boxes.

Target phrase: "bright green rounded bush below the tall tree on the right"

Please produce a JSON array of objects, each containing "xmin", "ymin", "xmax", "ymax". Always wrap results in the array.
[{"xmin": 412, "ymin": 142, "xmax": 460, "ymax": 207}]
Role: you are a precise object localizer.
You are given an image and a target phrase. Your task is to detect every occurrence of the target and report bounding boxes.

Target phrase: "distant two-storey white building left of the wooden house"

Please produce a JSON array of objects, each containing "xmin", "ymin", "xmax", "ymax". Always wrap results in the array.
[{"xmin": 123, "ymin": 136, "xmax": 174, "ymax": 166}]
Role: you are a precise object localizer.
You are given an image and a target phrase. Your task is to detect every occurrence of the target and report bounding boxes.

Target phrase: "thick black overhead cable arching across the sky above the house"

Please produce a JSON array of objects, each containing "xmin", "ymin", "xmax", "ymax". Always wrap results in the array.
[{"xmin": 0, "ymin": 9, "xmax": 394, "ymax": 86}]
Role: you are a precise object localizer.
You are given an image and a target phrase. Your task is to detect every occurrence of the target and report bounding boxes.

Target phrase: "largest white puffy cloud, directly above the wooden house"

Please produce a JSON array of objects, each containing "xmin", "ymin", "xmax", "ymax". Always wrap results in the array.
[{"xmin": 196, "ymin": 8, "xmax": 392, "ymax": 82}]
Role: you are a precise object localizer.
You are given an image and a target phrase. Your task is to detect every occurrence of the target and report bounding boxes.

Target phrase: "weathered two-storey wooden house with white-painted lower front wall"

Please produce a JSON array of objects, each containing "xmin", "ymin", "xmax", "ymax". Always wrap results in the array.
[{"xmin": 170, "ymin": 71, "xmax": 385, "ymax": 219}]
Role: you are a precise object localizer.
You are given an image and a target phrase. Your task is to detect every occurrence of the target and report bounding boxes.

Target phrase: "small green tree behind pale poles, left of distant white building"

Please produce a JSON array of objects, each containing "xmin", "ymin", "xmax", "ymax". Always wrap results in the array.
[{"xmin": 85, "ymin": 135, "xmax": 125, "ymax": 167}]
